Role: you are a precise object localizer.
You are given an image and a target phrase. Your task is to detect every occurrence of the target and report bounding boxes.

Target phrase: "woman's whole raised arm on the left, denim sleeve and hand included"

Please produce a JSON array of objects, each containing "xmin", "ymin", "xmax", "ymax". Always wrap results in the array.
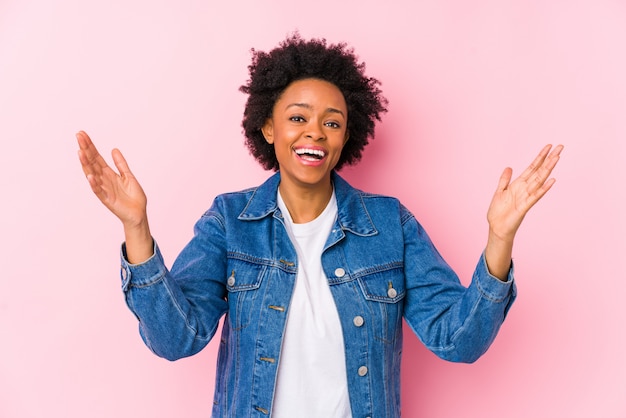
[{"xmin": 76, "ymin": 132, "xmax": 227, "ymax": 360}]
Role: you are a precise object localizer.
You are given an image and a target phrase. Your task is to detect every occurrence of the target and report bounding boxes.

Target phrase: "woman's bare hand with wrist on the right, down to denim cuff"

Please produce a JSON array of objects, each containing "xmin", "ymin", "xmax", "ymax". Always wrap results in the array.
[{"xmin": 485, "ymin": 145, "xmax": 563, "ymax": 280}]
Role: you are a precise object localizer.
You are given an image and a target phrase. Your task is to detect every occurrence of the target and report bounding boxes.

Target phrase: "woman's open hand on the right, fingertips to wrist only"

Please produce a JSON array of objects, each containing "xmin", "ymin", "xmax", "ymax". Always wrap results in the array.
[{"xmin": 487, "ymin": 145, "xmax": 563, "ymax": 238}]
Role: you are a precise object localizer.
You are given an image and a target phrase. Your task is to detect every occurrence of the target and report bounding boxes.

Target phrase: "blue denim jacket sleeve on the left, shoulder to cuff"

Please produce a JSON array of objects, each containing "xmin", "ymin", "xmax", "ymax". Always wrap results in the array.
[{"xmin": 121, "ymin": 206, "xmax": 228, "ymax": 360}]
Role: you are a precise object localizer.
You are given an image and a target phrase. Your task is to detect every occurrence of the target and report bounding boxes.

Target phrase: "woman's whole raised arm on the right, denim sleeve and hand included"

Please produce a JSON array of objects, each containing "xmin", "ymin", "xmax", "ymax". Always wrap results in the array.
[{"xmin": 404, "ymin": 146, "xmax": 563, "ymax": 362}]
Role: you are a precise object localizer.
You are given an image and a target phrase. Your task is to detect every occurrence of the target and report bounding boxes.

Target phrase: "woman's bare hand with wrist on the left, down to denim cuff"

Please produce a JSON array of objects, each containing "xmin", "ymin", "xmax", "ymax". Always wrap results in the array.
[{"xmin": 76, "ymin": 131, "xmax": 153, "ymax": 264}]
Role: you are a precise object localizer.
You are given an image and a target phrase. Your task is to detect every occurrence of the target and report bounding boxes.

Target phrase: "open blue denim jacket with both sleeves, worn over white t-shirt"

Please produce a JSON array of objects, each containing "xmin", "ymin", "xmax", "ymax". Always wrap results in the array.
[{"xmin": 122, "ymin": 173, "xmax": 515, "ymax": 418}]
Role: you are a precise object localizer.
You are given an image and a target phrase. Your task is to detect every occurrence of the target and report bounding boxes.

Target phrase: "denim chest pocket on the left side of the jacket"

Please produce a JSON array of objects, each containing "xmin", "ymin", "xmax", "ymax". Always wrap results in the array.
[{"xmin": 226, "ymin": 259, "xmax": 267, "ymax": 331}]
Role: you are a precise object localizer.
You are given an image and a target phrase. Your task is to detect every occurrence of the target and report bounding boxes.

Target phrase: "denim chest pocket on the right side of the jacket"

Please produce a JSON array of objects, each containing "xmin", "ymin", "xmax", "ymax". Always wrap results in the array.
[{"xmin": 358, "ymin": 265, "xmax": 406, "ymax": 343}]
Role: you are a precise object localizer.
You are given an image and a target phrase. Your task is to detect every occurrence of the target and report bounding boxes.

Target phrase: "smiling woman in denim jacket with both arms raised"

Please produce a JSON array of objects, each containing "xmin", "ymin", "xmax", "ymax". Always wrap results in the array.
[{"xmin": 77, "ymin": 36, "xmax": 562, "ymax": 417}]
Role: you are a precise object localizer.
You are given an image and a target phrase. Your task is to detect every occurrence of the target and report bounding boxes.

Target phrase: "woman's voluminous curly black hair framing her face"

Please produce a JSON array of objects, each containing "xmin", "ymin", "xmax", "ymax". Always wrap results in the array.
[{"xmin": 239, "ymin": 33, "xmax": 387, "ymax": 171}]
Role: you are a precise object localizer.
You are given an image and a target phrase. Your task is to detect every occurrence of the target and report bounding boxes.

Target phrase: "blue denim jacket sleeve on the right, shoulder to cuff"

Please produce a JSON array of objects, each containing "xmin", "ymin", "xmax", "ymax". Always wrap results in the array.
[{"xmin": 402, "ymin": 209, "xmax": 516, "ymax": 363}]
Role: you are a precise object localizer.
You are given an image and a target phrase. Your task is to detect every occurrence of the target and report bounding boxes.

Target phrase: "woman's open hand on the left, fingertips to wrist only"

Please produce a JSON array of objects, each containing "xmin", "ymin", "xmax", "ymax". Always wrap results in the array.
[{"xmin": 77, "ymin": 132, "xmax": 147, "ymax": 224}]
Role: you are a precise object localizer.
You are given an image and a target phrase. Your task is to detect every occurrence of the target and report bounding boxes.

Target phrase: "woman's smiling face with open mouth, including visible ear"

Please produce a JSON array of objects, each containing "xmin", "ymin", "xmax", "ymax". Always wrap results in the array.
[{"xmin": 262, "ymin": 79, "xmax": 348, "ymax": 191}]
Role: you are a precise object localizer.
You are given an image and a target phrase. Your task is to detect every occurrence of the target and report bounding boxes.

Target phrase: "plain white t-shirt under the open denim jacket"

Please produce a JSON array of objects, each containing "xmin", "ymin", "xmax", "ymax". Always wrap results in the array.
[{"xmin": 272, "ymin": 192, "xmax": 352, "ymax": 418}]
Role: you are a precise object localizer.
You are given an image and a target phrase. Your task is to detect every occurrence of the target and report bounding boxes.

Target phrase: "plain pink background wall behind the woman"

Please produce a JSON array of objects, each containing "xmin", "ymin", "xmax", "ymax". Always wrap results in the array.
[{"xmin": 0, "ymin": 0, "xmax": 626, "ymax": 418}]
